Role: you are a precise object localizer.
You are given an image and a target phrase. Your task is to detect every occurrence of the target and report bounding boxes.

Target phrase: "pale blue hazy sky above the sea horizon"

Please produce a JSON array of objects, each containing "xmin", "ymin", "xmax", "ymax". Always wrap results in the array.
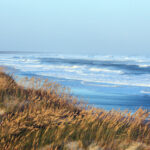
[{"xmin": 0, "ymin": 0, "xmax": 150, "ymax": 55}]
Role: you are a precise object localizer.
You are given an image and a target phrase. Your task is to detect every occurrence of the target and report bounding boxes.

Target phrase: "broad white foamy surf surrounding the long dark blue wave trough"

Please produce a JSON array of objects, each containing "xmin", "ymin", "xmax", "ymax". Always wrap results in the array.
[{"xmin": 0, "ymin": 55, "xmax": 150, "ymax": 87}]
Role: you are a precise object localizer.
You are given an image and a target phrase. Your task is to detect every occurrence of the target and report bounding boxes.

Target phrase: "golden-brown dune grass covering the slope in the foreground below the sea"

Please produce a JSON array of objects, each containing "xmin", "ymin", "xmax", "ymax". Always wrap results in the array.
[{"xmin": 0, "ymin": 68, "xmax": 150, "ymax": 150}]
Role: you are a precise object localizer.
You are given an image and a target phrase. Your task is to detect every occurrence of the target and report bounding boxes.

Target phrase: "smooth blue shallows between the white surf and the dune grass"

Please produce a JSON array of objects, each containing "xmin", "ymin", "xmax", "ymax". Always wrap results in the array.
[{"xmin": 1, "ymin": 66, "xmax": 150, "ymax": 113}]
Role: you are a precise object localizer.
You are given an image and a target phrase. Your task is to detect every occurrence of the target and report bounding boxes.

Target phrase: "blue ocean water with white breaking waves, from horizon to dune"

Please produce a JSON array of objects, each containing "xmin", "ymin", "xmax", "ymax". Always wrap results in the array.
[{"xmin": 0, "ymin": 52, "xmax": 150, "ymax": 112}]
